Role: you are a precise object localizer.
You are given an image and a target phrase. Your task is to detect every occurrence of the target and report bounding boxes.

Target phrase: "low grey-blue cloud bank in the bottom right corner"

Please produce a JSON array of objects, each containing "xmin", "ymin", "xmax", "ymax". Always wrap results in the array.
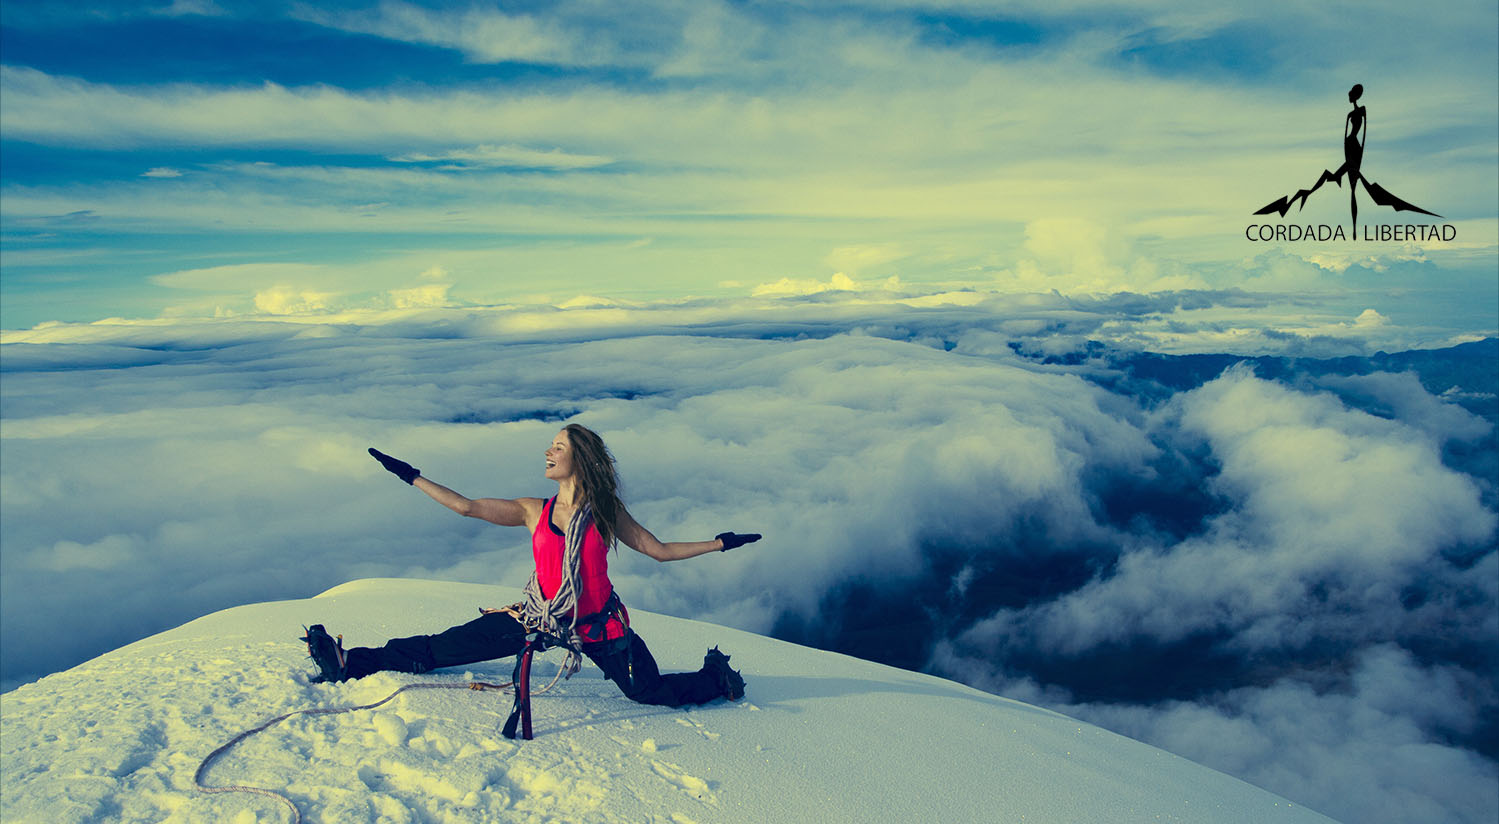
[{"xmin": 1031, "ymin": 646, "xmax": 1499, "ymax": 823}]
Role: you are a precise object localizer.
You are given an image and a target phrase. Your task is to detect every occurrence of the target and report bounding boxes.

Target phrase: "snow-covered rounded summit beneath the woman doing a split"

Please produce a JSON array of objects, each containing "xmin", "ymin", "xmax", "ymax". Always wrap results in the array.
[{"xmin": 0, "ymin": 578, "xmax": 1330, "ymax": 824}]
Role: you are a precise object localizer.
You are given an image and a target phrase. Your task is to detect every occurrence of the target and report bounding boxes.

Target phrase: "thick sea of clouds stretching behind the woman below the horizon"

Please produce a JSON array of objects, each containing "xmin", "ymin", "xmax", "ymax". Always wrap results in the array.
[{"xmin": 0, "ymin": 298, "xmax": 1499, "ymax": 821}]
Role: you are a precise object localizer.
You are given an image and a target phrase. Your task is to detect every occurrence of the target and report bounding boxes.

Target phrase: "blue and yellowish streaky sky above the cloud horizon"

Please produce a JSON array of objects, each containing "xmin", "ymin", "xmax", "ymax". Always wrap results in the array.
[{"xmin": 0, "ymin": 0, "xmax": 1499, "ymax": 345}]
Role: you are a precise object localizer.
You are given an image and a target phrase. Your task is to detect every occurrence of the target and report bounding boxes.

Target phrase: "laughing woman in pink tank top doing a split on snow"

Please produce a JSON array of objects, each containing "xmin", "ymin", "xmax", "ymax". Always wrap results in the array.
[{"xmin": 303, "ymin": 424, "xmax": 760, "ymax": 707}]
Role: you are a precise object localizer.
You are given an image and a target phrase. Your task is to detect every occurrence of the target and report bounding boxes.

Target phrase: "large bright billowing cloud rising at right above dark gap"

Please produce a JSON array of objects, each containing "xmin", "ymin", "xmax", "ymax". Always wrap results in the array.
[{"xmin": 970, "ymin": 370, "xmax": 1496, "ymax": 655}]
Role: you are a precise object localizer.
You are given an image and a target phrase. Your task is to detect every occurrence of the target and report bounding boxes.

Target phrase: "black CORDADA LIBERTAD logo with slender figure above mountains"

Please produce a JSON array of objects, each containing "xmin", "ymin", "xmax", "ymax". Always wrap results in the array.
[{"xmin": 1244, "ymin": 84, "xmax": 1457, "ymax": 241}]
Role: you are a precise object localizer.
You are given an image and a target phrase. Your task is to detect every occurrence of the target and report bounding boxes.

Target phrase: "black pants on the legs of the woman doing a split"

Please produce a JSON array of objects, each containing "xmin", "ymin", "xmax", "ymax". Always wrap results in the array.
[{"xmin": 345, "ymin": 613, "xmax": 721, "ymax": 707}]
